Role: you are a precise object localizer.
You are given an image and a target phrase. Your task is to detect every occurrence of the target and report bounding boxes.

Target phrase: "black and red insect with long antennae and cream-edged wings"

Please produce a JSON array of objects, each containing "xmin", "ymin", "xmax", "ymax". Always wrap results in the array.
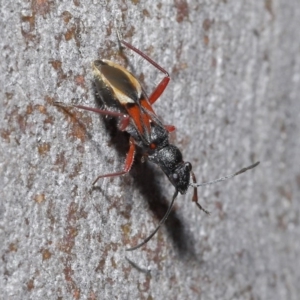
[{"xmin": 55, "ymin": 38, "xmax": 259, "ymax": 251}]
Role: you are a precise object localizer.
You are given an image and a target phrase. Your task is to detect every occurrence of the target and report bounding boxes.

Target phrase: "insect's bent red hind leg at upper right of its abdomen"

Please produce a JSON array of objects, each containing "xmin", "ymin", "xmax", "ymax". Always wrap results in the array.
[{"xmin": 120, "ymin": 40, "xmax": 170, "ymax": 104}]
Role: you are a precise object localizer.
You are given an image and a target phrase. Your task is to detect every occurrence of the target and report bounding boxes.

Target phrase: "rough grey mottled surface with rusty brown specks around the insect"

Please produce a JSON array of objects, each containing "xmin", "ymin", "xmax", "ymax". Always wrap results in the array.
[{"xmin": 0, "ymin": 0, "xmax": 300, "ymax": 300}]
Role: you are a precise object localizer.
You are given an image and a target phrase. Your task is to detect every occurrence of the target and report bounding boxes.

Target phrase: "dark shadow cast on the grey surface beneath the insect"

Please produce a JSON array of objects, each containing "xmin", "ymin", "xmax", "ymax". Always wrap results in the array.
[{"xmin": 93, "ymin": 85, "xmax": 195, "ymax": 256}]
